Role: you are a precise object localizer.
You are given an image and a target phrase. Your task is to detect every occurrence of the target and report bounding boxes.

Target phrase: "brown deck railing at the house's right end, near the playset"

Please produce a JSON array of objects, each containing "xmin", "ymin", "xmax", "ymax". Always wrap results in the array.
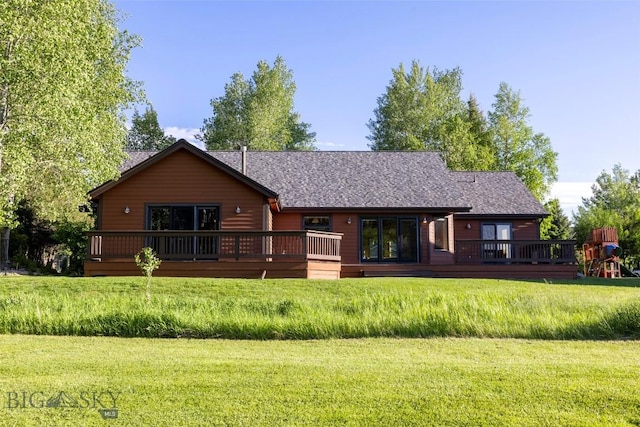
[{"xmin": 455, "ymin": 240, "xmax": 576, "ymax": 264}]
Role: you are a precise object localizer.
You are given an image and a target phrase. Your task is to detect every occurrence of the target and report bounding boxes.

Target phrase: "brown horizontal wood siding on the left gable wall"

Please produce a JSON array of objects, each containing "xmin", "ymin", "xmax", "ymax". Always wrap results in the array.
[{"xmin": 100, "ymin": 151, "xmax": 268, "ymax": 230}]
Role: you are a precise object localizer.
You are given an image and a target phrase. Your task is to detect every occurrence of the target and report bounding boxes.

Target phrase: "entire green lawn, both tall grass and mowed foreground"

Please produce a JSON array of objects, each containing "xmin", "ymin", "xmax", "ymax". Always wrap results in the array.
[{"xmin": 0, "ymin": 277, "xmax": 640, "ymax": 426}]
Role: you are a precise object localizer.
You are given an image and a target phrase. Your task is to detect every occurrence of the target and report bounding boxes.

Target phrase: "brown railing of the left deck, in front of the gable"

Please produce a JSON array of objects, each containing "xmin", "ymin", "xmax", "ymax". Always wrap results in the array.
[{"xmin": 87, "ymin": 231, "xmax": 342, "ymax": 261}]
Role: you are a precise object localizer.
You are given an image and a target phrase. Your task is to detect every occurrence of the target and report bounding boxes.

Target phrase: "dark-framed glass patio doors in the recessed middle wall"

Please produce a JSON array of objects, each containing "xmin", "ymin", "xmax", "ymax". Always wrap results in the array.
[{"xmin": 360, "ymin": 217, "xmax": 418, "ymax": 262}]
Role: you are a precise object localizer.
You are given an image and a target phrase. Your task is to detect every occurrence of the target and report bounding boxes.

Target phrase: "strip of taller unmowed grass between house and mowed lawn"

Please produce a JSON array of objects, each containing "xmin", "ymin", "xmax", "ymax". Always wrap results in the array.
[{"xmin": 0, "ymin": 277, "xmax": 640, "ymax": 340}]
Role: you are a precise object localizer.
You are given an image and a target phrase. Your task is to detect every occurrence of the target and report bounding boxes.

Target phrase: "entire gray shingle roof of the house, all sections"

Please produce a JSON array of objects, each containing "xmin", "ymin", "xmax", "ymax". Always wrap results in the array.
[{"xmin": 121, "ymin": 145, "xmax": 546, "ymax": 216}]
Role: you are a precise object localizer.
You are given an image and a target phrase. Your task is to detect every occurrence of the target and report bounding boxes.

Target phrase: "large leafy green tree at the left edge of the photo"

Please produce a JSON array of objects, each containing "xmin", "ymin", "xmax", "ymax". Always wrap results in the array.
[{"xmin": 0, "ymin": 0, "xmax": 138, "ymax": 268}]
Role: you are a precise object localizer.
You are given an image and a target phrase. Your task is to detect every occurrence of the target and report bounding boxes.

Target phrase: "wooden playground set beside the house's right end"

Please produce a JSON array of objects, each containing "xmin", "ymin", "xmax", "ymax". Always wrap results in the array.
[{"xmin": 582, "ymin": 227, "xmax": 622, "ymax": 278}]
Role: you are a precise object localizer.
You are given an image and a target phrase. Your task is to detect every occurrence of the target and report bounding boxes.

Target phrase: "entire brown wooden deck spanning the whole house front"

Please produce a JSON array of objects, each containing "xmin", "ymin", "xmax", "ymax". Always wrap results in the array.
[{"xmin": 85, "ymin": 231, "xmax": 577, "ymax": 279}]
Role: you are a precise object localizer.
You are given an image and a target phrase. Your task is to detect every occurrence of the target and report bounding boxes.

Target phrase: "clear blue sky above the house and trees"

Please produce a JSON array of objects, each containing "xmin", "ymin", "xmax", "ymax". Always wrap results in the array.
[{"xmin": 114, "ymin": 0, "xmax": 640, "ymax": 211}]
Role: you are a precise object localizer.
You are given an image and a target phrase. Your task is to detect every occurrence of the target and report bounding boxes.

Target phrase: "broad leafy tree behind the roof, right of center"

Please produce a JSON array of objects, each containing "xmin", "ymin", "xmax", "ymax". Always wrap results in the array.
[{"xmin": 367, "ymin": 60, "xmax": 491, "ymax": 170}]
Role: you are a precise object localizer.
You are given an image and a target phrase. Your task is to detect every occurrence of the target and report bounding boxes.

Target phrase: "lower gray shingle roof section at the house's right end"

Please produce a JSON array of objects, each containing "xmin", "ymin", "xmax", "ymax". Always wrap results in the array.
[{"xmin": 451, "ymin": 172, "xmax": 547, "ymax": 216}]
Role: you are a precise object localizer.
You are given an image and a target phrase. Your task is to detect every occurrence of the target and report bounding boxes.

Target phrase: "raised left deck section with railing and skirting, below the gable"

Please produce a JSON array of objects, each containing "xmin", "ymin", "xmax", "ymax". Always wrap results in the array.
[{"xmin": 84, "ymin": 231, "xmax": 342, "ymax": 279}]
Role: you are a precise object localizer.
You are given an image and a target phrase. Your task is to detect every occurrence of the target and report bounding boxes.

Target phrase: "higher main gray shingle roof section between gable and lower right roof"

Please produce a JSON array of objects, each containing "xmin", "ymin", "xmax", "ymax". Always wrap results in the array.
[{"xmin": 209, "ymin": 151, "xmax": 470, "ymax": 210}]
